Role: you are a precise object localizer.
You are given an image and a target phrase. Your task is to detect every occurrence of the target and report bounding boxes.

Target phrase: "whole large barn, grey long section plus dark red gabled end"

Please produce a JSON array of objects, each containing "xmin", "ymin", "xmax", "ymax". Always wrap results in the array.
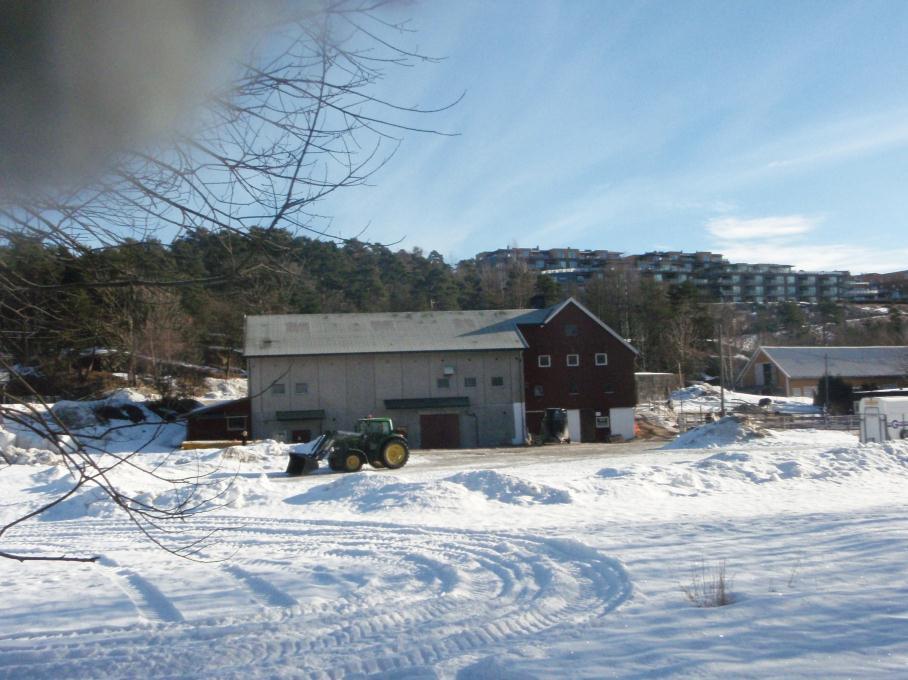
[{"xmin": 245, "ymin": 299, "xmax": 636, "ymax": 448}]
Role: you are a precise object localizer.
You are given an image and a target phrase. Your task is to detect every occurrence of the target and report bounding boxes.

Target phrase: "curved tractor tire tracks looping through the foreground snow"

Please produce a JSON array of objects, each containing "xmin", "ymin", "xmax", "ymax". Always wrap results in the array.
[{"xmin": 0, "ymin": 518, "xmax": 632, "ymax": 678}]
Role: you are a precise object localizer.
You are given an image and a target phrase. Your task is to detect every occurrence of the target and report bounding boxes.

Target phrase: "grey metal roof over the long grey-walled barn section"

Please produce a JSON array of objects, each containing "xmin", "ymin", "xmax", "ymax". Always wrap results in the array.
[{"xmin": 245, "ymin": 308, "xmax": 551, "ymax": 357}]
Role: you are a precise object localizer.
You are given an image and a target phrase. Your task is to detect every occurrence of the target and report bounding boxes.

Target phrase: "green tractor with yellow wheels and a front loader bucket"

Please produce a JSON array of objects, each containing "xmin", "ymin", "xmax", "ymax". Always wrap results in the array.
[{"xmin": 287, "ymin": 418, "xmax": 410, "ymax": 475}]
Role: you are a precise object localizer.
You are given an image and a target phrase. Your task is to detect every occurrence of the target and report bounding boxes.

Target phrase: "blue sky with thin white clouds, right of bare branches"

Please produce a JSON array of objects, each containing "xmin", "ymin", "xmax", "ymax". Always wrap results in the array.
[{"xmin": 322, "ymin": 0, "xmax": 908, "ymax": 272}]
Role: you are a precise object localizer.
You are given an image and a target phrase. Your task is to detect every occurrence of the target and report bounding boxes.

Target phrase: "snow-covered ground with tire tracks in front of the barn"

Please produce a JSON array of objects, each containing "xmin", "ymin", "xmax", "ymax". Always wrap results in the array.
[{"xmin": 0, "ymin": 412, "xmax": 908, "ymax": 678}]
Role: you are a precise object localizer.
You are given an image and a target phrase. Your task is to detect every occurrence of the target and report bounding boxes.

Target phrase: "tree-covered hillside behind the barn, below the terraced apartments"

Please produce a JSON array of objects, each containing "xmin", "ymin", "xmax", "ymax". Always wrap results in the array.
[{"xmin": 0, "ymin": 228, "xmax": 908, "ymax": 397}]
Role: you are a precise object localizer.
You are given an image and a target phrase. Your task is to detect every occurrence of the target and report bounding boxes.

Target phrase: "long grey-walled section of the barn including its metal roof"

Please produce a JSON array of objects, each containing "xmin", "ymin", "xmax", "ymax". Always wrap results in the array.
[{"xmin": 245, "ymin": 310, "xmax": 545, "ymax": 448}]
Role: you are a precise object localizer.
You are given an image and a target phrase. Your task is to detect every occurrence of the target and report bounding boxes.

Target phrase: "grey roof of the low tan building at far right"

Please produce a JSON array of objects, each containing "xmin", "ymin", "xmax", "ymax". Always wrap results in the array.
[{"xmin": 762, "ymin": 346, "xmax": 908, "ymax": 378}]
